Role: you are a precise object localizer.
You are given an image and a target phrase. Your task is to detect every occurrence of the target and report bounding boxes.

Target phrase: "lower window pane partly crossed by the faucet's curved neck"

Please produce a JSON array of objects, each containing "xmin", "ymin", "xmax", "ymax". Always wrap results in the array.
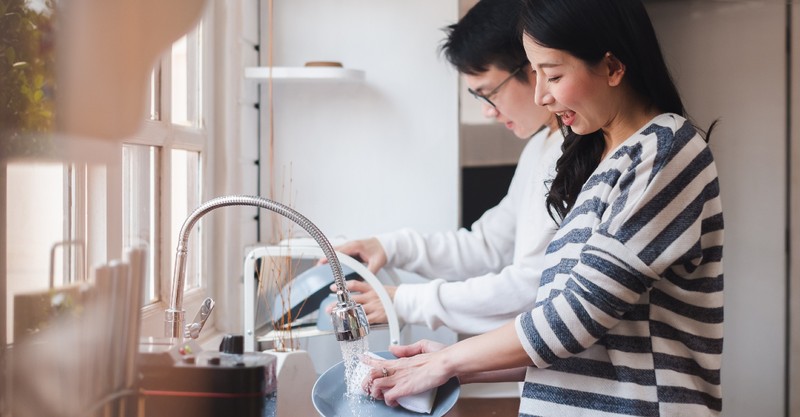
[{"xmin": 170, "ymin": 149, "xmax": 204, "ymax": 290}]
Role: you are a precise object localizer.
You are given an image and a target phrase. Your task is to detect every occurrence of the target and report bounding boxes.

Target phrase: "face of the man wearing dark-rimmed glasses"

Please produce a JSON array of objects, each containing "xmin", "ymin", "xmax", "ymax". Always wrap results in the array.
[{"xmin": 464, "ymin": 65, "xmax": 550, "ymax": 139}]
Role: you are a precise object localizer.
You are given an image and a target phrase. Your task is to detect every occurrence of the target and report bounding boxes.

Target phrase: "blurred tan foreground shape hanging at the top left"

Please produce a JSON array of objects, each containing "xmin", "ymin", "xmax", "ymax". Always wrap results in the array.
[{"xmin": 56, "ymin": 0, "xmax": 206, "ymax": 139}]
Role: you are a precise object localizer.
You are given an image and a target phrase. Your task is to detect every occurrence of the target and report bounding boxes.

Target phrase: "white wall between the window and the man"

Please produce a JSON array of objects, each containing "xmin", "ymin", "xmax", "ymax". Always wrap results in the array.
[{"xmin": 253, "ymin": 0, "xmax": 458, "ymax": 239}]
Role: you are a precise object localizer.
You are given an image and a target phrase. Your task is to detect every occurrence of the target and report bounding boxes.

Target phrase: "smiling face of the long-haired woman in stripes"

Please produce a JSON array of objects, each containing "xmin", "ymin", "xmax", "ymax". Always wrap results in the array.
[{"xmin": 523, "ymin": 35, "xmax": 616, "ymax": 135}]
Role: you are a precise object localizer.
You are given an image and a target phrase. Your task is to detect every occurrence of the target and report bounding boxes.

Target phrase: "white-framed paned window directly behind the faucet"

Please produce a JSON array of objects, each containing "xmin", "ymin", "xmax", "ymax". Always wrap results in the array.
[{"xmin": 130, "ymin": 17, "xmax": 208, "ymax": 337}]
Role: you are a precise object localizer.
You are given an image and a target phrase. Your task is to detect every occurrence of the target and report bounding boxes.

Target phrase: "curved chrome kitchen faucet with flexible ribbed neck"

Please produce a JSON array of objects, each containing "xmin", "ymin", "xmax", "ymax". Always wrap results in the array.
[{"xmin": 164, "ymin": 195, "xmax": 369, "ymax": 342}]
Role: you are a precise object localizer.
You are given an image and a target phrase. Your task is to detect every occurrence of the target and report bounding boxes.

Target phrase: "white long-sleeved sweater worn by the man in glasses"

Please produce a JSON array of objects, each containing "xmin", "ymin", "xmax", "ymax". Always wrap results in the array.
[{"xmin": 378, "ymin": 129, "xmax": 563, "ymax": 334}]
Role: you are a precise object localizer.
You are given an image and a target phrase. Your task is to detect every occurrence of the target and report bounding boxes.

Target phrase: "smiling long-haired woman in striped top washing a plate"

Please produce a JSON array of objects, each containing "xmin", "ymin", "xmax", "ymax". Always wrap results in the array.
[{"xmin": 365, "ymin": 0, "xmax": 723, "ymax": 416}]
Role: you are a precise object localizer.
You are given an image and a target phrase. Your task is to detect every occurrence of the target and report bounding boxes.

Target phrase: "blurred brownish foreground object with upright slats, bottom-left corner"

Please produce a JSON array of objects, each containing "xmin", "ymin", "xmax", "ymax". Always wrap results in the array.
[{"xmin": 9, "ymin": 248, "xmax": 147, "ymax": 417}]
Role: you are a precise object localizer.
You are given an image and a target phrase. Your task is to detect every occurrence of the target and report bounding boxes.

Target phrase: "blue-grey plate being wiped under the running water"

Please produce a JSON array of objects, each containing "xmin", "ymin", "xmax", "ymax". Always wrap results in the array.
[{"xmin": 311, "ymin": 351, "xmax": 461, "ymax": 417}]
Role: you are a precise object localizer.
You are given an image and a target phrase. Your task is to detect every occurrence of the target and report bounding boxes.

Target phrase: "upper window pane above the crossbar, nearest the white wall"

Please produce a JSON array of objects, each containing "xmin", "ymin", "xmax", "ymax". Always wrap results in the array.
[{"xmin": 171, "ymin": 24, "xmax": 203, "ymax": 127}]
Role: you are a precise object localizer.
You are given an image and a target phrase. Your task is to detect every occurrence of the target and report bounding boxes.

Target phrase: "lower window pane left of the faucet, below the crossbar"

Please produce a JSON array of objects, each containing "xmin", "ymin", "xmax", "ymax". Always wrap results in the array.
[{"xmin": 122, "ymin": 144, "xmax": 160, "ymax": 305}]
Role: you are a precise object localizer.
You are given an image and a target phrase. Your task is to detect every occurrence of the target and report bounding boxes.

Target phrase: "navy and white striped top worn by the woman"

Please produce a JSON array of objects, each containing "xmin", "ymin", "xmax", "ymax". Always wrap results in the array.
[{"xmin": 516, "ymin": 114, "xmax": 723, "ymax": 417}]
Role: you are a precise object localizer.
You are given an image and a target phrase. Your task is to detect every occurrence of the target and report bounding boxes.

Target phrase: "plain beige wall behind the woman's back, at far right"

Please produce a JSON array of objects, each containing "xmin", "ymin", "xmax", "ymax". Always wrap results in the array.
[{"xmin": 648, "ymin": 0, "xmax": 787, "ymax": 417}]
